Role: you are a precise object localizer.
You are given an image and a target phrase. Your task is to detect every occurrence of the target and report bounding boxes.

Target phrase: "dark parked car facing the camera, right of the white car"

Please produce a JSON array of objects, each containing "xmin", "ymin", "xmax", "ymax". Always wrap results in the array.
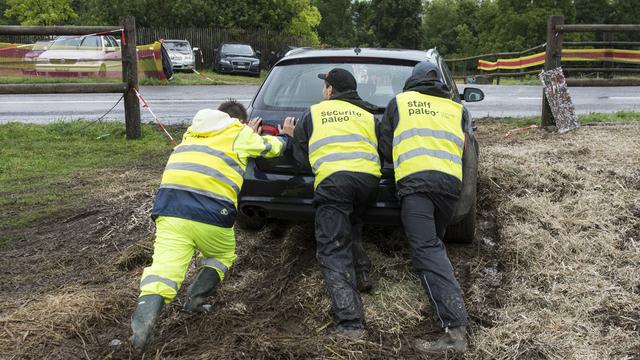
[{"xmin": 213, "ymin": 43, "xmax": 260, "ymax": 76}]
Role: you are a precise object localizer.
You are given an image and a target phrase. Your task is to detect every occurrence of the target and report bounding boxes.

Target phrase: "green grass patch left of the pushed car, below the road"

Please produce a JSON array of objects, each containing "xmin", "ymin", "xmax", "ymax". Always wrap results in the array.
[{"xmin": 0, "ymin": 121, "xmax": 179, "ymax": 230}]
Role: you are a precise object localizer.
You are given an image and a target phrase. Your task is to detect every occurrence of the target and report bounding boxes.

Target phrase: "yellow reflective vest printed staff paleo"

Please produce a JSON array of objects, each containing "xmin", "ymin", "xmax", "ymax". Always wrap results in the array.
[{"xmin": 393, "ymin": 91, "xmax": 464, "ymax": 182}]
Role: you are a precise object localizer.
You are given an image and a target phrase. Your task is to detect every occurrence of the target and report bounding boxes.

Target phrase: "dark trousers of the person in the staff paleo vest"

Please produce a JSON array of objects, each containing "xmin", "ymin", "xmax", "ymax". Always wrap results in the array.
[{"xmin": 401, "ymin": 193, "xmax": 468, "ymax": 328}]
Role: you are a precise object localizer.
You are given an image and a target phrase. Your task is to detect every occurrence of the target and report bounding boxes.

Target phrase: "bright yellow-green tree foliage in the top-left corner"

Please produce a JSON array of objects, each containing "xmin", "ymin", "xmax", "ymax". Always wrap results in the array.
[{"xmin": 4, "ymin": 0, "xmax": 78, "ymax": 25}]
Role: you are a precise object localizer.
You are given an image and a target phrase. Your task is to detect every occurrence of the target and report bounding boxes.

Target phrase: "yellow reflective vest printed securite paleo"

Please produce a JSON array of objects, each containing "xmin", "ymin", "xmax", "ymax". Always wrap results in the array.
[{"xmin": 309, "ymin": 100, "xmax": 380, "ymax": 187}]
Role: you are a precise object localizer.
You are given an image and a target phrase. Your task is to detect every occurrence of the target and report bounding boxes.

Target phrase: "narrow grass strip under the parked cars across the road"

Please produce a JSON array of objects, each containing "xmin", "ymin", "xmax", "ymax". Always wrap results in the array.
[{"xmin": 0, "ymin": 70, "xmax": 267, "ymax": 86}]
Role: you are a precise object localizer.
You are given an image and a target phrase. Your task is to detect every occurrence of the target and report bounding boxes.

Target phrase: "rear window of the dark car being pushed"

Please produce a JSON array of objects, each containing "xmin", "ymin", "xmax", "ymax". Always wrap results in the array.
[{"xmin": 254, "ymin": 63, "xmax": 413, "ymax": 110}]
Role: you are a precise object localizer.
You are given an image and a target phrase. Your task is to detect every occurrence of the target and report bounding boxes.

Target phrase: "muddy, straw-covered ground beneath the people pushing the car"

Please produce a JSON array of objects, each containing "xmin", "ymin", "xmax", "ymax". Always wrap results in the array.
[{"xmin": 0, "ymin": 123, "xmax": 640, "ymax": 359}]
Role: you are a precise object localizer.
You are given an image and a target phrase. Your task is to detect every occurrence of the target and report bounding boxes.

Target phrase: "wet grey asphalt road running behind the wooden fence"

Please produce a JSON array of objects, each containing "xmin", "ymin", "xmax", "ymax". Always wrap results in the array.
[{"xmin": 0, "ymin": 85, "xmax": 640, "ymax": 124}]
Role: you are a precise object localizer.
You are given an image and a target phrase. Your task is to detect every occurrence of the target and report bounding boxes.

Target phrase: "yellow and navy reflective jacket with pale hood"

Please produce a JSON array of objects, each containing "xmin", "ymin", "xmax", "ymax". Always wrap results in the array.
[{"xmin": 151, "ymin": 121, "xmax": 288, "ymax": 227}]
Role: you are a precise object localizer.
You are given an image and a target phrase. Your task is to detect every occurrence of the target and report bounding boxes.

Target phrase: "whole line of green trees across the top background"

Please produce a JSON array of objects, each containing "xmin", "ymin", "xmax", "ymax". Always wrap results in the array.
[{"xmin": 0, "ymin": 0, "xmax": 640, "ymax": 56}]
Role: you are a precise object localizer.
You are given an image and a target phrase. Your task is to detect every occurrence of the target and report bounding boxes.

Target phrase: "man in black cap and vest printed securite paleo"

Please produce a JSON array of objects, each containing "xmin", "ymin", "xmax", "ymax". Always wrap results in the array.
[{"xmin": 293, "ymin": 68, "xmax": 380, "ymax": 338}]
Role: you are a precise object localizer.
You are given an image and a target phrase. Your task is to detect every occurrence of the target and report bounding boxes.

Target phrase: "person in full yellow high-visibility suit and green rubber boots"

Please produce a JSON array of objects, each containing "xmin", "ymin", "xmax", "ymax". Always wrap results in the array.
[{"xmin": 131, "ymin": 101, "xmax": 294, "ymax": 350}]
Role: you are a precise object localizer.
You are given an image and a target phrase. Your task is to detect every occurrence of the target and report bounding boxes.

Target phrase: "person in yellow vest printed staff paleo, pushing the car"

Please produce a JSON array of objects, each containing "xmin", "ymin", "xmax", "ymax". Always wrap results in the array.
[{"xmin": 380, "ymin": 61, "xmax": 468, "ymax": 353}]
